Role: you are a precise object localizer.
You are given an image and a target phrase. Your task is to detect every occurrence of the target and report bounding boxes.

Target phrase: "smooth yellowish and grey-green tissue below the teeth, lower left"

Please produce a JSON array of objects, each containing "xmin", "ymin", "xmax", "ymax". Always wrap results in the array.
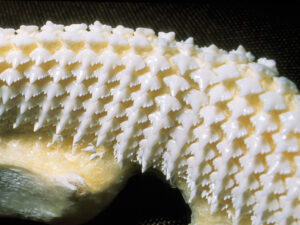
[{"xmin": 0, "ymin": 133, "xmax": 131, "ymax": 224}]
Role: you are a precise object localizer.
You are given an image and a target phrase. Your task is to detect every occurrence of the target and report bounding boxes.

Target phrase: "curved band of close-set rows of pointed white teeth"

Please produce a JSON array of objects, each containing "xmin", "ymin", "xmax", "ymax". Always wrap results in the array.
[{"xmin": 0, "ymin": 22, "xmax": 300, "ymax": 225}]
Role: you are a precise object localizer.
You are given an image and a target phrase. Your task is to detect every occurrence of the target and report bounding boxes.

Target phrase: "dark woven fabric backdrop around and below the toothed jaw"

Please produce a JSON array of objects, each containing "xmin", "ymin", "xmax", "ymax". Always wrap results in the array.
[{"xmin": 0, "ymin": 1, "xmax": 300, "ymax": 225}]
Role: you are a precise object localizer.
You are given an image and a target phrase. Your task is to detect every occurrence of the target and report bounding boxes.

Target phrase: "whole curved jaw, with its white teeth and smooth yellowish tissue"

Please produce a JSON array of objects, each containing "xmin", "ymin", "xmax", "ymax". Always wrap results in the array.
[{"xmin": 0, "ymin": 21, "xmax": 300, "ymax": 225}]
